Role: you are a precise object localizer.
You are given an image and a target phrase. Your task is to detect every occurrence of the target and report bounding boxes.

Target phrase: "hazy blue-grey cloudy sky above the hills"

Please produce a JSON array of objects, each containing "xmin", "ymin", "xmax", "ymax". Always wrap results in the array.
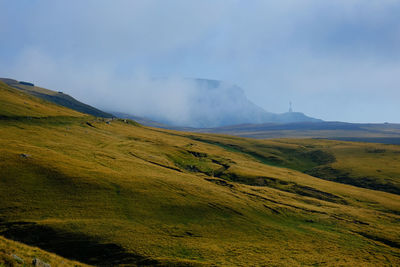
[{"xmin": 0, "ymin": 0, "xmax": 400, "ymax": 123}]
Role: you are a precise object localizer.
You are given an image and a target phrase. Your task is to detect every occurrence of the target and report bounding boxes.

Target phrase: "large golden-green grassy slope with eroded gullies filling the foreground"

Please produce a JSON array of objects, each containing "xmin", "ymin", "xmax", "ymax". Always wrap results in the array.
[{"xmin": 0, "ymin": 82, "xmax": 400, "ymax": 266}]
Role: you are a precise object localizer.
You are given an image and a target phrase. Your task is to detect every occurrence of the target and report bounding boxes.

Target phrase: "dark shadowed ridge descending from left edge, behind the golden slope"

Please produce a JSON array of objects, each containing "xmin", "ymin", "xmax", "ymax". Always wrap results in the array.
[{"xmin": 0, "ymin": 78, "xmax": 113, "ymax": 118}]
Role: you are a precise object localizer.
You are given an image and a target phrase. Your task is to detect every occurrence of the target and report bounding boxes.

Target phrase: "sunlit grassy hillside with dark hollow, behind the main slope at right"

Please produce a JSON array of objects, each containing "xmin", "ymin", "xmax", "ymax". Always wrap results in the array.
[{"xmin": 175, "ymin": 134, "xmax": 400, "ymax": 195}]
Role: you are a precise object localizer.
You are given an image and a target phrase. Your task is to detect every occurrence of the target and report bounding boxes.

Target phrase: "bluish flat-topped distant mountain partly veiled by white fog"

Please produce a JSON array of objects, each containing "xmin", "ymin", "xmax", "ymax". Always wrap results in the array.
[{"xmin": 106, "ymin": 78, "xmax": 318, "ymax": 128}]
